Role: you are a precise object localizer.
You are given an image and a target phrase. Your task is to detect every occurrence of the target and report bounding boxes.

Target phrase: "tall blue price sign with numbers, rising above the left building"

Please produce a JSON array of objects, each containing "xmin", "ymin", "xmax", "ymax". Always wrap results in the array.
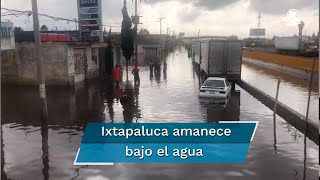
[{"xmin": 78, "ymin": 0, "xmax": 101, "ymax": 40}]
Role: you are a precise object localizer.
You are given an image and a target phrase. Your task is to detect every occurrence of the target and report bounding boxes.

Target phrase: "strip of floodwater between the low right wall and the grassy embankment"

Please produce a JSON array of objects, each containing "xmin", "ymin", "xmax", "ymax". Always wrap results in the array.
[{"xmin": 242, "ymin": 63, "xmax": 319, "ymax": 124}]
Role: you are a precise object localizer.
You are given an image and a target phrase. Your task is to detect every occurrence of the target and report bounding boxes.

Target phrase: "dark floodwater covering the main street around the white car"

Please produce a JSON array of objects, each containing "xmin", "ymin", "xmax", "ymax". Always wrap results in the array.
[{"xmin": 1, "ymin": 48, "xmax": 319, "ymax": 180}]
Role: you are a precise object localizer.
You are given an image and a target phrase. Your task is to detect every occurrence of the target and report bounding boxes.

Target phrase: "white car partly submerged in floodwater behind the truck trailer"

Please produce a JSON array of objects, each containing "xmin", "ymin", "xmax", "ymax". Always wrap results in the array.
[{"xmin": 199, "ymin": 77, "xmax": 231, "ymax": 98}]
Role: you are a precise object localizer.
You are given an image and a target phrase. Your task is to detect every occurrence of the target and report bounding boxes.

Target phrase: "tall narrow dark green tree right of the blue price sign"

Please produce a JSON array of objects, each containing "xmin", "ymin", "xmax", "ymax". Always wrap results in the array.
[{"xmin": 121, "ymin": 0, "xmax": 135, "ymax": 80}]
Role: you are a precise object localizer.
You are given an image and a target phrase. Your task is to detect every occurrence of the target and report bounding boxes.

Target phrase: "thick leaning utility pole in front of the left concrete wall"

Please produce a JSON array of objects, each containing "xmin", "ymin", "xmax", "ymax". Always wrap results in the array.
[{"xmin": 32, "ymin": 0, "xmax": 48, "ymax": 119}]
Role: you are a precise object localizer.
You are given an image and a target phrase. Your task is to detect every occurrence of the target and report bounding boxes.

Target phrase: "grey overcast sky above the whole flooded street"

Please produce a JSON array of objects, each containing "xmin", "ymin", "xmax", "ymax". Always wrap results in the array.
[{"xmin": 1, "ymin": 0, "xmax": 319, "ymax": 38}]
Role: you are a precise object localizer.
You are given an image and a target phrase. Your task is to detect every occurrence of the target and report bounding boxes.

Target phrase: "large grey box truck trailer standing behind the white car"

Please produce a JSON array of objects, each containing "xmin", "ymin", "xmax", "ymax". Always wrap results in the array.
[{"xmin": 200, "ymin": 40, "xmax": 242, "ymax": 81}]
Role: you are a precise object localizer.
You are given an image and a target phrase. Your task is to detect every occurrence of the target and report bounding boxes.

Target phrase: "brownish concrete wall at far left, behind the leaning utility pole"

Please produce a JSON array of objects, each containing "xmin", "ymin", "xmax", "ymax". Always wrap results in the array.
[{"xmin": 1, "ymin": 42, "xmax": 68, "ymax": 85}]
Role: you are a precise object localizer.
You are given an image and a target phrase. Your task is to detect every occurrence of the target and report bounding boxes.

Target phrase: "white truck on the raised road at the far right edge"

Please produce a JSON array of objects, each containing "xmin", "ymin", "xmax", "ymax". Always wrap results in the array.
[{"xmin": 275, "ymin": 36, "xmax": 319, "ymax": 56}]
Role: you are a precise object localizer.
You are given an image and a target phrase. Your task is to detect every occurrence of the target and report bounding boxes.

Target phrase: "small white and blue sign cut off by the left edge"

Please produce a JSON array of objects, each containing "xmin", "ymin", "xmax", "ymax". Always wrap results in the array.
[{"xmin": 0, "ymin": 22, "xmax": 15, "ymax": 50}]
